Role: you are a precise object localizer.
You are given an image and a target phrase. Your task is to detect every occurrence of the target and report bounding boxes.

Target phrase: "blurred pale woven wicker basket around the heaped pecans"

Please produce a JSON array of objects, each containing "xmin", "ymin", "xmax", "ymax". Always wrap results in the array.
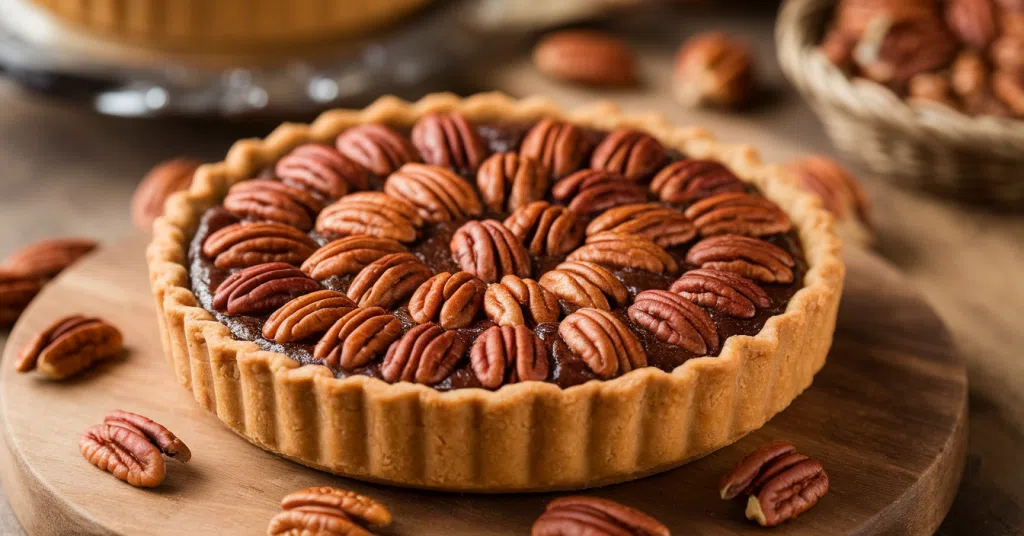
[{"xmin": 775, "ymin": 0, "xmax": 1024, "ymax": 207}]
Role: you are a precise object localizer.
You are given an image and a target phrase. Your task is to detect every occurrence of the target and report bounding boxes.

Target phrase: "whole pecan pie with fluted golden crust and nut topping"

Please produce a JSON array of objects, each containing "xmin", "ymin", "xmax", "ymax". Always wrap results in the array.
[{"xmin": 147, "ymin": 93, "xmax": 844, "ymax": 492}]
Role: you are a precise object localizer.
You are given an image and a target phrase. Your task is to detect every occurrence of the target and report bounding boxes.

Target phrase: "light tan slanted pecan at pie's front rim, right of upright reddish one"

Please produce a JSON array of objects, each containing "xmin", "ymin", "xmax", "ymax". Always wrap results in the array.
[{"xmin": 558, "ymin": 307, "xmax": 647, "ymax": 379}]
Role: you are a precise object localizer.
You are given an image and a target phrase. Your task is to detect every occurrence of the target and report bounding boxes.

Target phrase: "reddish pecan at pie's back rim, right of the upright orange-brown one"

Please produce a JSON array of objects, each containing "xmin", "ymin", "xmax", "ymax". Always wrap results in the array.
[{"xmin": 590, "ymin": 128, "xmax": 665, "ymax": 180}]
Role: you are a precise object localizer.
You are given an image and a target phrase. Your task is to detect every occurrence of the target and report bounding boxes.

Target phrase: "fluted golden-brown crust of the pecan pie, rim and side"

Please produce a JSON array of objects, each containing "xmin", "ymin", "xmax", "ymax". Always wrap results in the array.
[{"xmin": 146, "ymin": 93, "xmax": 845, "ymax": 492}]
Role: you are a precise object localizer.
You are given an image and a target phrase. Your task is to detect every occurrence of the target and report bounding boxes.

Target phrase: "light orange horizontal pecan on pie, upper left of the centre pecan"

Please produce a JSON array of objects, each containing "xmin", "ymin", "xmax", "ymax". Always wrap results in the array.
[{"xmin": 316, "ymin": 192, "xmax": 423, "ymax": 243}]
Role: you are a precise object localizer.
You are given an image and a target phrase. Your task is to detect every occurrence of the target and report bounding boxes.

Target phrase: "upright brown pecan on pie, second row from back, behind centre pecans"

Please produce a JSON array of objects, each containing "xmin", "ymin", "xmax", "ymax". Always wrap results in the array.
[{"xmin": 476, "ymin": 153, "xmax": 548, "ymax": 212}]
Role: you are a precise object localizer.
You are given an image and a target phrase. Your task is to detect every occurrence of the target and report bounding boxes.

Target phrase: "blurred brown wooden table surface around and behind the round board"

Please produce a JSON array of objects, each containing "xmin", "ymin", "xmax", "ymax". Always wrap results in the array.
[{"xmin": 0, "ymin": 5, "xmax": 1024, "ymax": 535}]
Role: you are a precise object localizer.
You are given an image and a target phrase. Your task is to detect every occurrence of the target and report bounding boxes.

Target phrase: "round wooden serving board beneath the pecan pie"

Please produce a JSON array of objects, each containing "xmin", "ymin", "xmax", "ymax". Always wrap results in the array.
[{"xmin": 0, "ymin": 237, "xmax": 967, "ymax": 536}]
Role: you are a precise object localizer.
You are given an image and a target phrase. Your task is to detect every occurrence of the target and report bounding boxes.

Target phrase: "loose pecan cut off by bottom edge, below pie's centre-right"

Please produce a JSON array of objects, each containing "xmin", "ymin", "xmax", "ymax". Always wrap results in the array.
[{"xmin": 531, "ymin": 496, "xmax": 670, "ymax": 536}]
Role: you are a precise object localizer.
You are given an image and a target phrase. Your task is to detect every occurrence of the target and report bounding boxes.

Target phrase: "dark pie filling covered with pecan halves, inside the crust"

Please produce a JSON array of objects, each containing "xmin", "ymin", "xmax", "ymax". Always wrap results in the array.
[{"xmin": 189, "ymin": 112, "xmax": 806, "ymax": 389}]
